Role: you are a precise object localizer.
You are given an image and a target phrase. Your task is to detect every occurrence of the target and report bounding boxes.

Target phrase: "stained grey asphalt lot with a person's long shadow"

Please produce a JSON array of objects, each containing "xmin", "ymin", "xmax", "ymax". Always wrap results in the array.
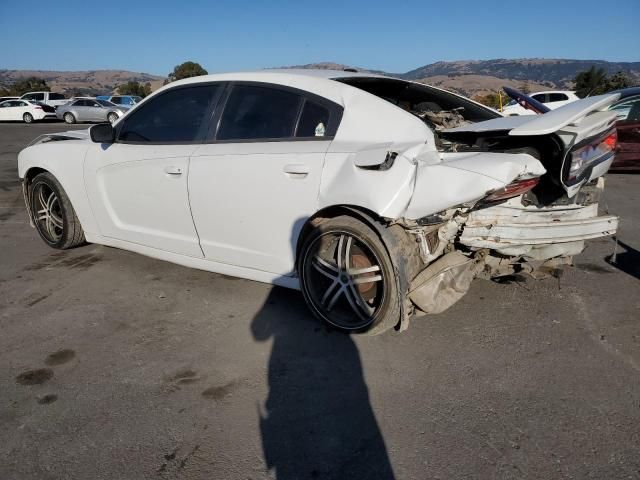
[{"xmin": 0, "ymin": 123, "xmax": 640, "ymax": 480}]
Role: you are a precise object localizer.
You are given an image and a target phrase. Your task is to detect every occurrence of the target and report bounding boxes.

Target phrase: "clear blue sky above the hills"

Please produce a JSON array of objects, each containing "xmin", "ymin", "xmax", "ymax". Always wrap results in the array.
[{"xmin": 0, "ymin": 0, "xmax": 640, "ymax": 75}]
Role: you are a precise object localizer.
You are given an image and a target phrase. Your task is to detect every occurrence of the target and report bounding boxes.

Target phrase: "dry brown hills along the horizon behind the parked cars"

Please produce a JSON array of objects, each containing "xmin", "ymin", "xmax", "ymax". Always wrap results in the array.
[{"xmin": 0, "ymin": 58, "xmax": 640, "ymax": 96}]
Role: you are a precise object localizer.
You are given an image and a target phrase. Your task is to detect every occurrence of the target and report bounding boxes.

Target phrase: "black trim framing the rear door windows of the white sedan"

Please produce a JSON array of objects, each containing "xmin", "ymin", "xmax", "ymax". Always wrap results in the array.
[{"xmin": 208, "ymin": 80, "xmax": 344, "ymax": 145}]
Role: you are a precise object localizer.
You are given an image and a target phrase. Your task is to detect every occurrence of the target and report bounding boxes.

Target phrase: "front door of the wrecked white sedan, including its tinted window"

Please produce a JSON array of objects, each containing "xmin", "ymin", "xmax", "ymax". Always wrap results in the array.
[{"xmin": 84, "ymin": 85, "xmax": 221, "ymax": 258}]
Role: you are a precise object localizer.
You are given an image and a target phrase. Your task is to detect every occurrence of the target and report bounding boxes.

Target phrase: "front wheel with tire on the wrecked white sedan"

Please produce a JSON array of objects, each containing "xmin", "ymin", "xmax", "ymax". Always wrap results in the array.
[{"xmin": 29, "ymin": 172, "xmax": 85, "ymax": 250}]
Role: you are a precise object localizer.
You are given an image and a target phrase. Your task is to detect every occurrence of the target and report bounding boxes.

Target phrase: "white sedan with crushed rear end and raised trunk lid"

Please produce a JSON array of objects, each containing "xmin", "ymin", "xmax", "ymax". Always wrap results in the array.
[{"xmin": 18, "ymin": 70, "xmax": 618, "ymax": 333}]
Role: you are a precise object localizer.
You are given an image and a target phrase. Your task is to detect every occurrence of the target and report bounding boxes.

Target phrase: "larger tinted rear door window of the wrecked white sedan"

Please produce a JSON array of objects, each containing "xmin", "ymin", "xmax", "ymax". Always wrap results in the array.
[{"xmin": 216, "ymin": 85, "xmax": 301, "ymax": 140}]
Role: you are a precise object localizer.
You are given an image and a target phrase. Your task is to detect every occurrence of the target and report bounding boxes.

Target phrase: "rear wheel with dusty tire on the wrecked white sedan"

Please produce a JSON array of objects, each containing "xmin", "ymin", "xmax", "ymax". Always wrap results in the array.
[{"xmin": 298, "ymin": 216, "xmax": 400, "ymax": 335}]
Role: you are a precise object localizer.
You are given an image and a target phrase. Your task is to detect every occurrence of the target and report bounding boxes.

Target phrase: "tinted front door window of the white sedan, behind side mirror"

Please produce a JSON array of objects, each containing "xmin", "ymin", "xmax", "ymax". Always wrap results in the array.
[{"xmin": 118, "ymin": 85, "xmax": 220, "ymax": 143}]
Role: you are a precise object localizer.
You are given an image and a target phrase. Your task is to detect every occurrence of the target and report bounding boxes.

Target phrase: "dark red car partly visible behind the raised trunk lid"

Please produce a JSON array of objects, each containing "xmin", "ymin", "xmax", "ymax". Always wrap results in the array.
[{"xmin": 609, "ymin": 87, "xmax": 640, "ymax": 170}]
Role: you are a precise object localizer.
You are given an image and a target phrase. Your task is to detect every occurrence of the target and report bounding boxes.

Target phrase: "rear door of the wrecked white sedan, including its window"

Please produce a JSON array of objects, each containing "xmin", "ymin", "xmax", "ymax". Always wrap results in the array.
[{"xmin": 189, "ymin": 82, "xmax": 342, "ymax": 275}]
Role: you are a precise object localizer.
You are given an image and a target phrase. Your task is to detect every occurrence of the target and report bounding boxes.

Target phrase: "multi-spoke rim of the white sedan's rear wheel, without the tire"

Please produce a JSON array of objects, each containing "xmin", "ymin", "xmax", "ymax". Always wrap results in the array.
[{"xmin": 302, "ymin": 232, "xmax": 386, "ymax": 330}]
